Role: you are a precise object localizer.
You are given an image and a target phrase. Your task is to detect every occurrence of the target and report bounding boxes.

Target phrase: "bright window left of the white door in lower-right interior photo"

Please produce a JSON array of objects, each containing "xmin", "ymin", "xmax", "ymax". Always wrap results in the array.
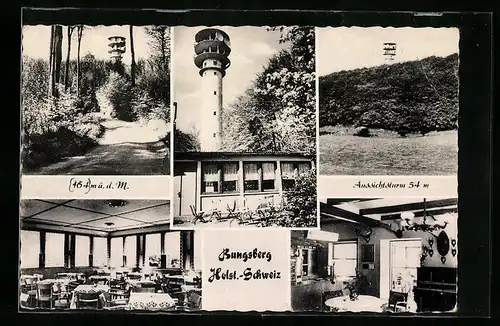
[{"xmin": 333, "ymin": 242, "xmax": 358, "ymax": 278}]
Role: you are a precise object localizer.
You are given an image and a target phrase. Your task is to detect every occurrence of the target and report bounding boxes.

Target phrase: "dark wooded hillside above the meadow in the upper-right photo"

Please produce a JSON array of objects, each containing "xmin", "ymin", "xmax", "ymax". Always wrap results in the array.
[{"xmin": 319, "ymin": 54, "xmax": 458, "ymax": 134}]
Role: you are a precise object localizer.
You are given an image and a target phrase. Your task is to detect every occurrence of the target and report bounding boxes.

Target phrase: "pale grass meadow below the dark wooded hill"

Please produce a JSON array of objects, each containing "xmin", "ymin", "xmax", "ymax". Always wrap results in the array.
[{"xmin": 319, "ymin": 127, "xmax": 458, "ymax": 175}]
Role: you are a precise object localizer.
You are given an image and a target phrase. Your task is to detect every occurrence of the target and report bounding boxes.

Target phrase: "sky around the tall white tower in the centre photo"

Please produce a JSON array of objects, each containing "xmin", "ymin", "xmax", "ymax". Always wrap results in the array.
[{"xmin": 172, "ymin": 26, "xmax": 287, "ymax": 131}]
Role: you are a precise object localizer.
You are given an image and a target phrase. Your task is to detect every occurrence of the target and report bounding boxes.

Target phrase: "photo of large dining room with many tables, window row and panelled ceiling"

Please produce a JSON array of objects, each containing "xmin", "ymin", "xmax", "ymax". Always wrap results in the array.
[{"xmin": 19, "ymin": 199, "xmax": 202, "ymax": 312}]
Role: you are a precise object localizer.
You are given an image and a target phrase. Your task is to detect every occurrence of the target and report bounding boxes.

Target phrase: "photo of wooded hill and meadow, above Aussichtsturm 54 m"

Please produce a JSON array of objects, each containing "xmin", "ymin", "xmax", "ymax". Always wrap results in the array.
[{"xmin": 316, "ymin": 27, "xmax": 459, "ymax": 175}]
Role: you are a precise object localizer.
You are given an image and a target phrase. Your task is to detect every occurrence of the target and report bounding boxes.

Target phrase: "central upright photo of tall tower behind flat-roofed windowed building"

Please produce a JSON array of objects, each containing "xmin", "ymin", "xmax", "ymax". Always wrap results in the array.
[{"xmin": 172, "ymin": 26, "xmax": 318, "ymax": 228}]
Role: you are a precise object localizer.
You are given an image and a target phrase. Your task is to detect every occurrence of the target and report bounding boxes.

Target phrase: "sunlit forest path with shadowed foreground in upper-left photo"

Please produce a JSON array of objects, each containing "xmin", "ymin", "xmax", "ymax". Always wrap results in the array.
[{"xmin": 28, "ymin": 119, "xmax": 170, "ymax": 175}]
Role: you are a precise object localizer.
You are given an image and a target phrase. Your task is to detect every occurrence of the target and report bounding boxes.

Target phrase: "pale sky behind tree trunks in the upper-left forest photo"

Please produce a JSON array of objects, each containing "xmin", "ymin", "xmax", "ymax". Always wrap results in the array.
[{"xmin": 22, "ymin": 25, "xmax": 153, "ymax": 64}]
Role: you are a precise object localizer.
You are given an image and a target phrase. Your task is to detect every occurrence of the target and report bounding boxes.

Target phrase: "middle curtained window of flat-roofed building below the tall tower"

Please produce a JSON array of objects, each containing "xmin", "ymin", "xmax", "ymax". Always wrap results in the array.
[{"xmin": 243, "ymin": 162, "xmax": 276, "ymax": 192}]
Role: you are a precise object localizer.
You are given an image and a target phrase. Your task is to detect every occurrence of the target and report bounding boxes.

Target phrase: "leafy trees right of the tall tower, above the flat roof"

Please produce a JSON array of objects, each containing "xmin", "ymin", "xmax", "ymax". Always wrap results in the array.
[{"xmin": 222, "ymin": 27, "xmax": 316, "ymax": 154}]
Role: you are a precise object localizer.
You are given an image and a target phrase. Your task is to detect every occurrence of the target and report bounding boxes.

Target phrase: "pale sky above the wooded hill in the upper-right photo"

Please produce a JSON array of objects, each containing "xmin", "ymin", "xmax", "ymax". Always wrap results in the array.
[{"xmin": 316, "ymin": 27, "xmax": 459, "ymax": 76}]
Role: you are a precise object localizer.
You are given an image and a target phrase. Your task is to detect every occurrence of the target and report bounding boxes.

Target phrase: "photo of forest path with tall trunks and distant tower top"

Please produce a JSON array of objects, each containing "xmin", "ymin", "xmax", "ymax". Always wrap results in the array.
[{"xmin": 21, "ymin": 25, "xmax": 171, "ymax": 175}]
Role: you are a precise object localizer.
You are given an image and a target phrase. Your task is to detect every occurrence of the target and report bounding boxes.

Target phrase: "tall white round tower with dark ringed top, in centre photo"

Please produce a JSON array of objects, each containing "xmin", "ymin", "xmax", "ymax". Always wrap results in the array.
[{"xmin": 194, "ymin": 28, "xmax": 231, "ymax": 152}]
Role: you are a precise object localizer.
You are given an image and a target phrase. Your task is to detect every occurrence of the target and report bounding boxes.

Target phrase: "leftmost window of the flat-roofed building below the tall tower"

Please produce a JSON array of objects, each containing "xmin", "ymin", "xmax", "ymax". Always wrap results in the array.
[{"xmin": 202, "ymin": 162, "xmax": 238, "ymax": 194}]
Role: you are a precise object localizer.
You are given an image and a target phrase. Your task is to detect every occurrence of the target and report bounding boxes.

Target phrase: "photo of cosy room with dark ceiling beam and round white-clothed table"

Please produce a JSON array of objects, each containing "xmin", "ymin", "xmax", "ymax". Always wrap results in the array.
[{"xmin": 291, "ymin": 197, "xmax": 458, "ymax": 313}]
